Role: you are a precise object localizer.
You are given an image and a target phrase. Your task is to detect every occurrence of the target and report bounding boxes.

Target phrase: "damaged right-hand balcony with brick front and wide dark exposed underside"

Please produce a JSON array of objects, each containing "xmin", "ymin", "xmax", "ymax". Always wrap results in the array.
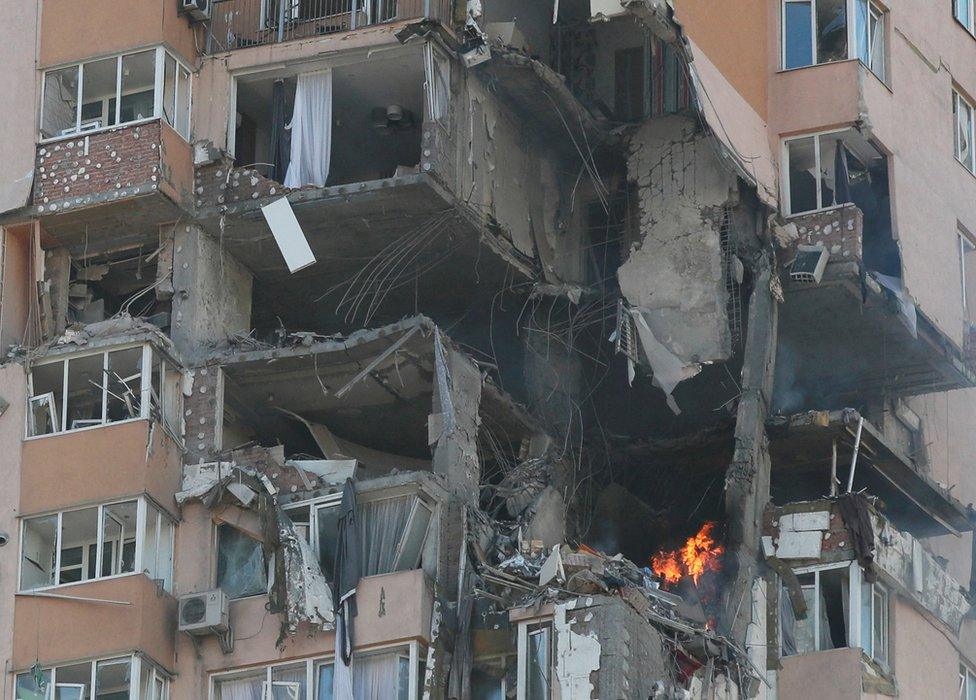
[{"xmin": 774, "ymin": 204, "xmax": 976, "ymax": 413}]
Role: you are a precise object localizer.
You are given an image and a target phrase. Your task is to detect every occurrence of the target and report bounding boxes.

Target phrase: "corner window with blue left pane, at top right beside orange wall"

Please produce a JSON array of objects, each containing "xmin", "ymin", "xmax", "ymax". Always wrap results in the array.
[{"xmin": 782, "ymin": 0, "xmax": 886, "ymax": 80}]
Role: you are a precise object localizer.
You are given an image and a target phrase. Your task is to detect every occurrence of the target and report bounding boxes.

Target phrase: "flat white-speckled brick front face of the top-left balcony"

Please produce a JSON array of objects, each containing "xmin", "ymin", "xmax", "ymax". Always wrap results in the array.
[{"xmin": 33, "ymin": 121, "xmax": 162, "ymax": 213}]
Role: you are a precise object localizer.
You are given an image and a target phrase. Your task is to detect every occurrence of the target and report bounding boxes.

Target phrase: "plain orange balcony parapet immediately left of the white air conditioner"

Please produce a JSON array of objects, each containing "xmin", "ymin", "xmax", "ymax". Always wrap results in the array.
[{"xmin": 12, "ymin": 574, "xmax": 177, "ymax": 670}]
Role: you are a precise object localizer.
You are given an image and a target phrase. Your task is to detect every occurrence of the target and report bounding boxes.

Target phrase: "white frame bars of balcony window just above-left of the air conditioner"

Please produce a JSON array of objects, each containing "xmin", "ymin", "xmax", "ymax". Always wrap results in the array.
[{"xmin": 17, "ymin": 496, "xmax": 176, "ymax": 595}]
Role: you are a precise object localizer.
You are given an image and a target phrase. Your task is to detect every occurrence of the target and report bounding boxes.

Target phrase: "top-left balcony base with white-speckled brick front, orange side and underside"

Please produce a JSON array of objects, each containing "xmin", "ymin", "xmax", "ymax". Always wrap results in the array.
[{"xmin": 33, "ymin": 119, "xmax": 193, "ymax": 258}]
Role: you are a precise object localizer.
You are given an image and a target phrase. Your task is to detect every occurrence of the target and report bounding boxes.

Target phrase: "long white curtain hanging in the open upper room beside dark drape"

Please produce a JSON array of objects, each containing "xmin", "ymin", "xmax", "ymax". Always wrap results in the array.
[{"xmin": 284, "ymin": 68, "xmax": 332, "ymax": 188}]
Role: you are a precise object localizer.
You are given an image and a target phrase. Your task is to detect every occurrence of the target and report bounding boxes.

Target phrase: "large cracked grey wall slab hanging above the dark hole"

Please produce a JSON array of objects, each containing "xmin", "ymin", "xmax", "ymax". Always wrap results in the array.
[{"xmin": 617, "ymin": 116, "xmax": 734, "ymax": 365}]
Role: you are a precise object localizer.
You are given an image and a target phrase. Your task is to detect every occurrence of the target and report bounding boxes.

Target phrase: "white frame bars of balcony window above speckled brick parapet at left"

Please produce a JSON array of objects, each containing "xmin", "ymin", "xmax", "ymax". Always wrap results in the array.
[{"xmin": 38, "ymin": 46, "xmax": 193, "ymax": 143}]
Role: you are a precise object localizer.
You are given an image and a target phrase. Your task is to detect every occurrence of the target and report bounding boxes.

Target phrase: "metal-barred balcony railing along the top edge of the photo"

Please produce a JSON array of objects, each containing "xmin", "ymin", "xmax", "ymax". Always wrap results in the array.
[{"xmin": 207, "ymin": 0, "xmax": 451, "ymax": 53}]
